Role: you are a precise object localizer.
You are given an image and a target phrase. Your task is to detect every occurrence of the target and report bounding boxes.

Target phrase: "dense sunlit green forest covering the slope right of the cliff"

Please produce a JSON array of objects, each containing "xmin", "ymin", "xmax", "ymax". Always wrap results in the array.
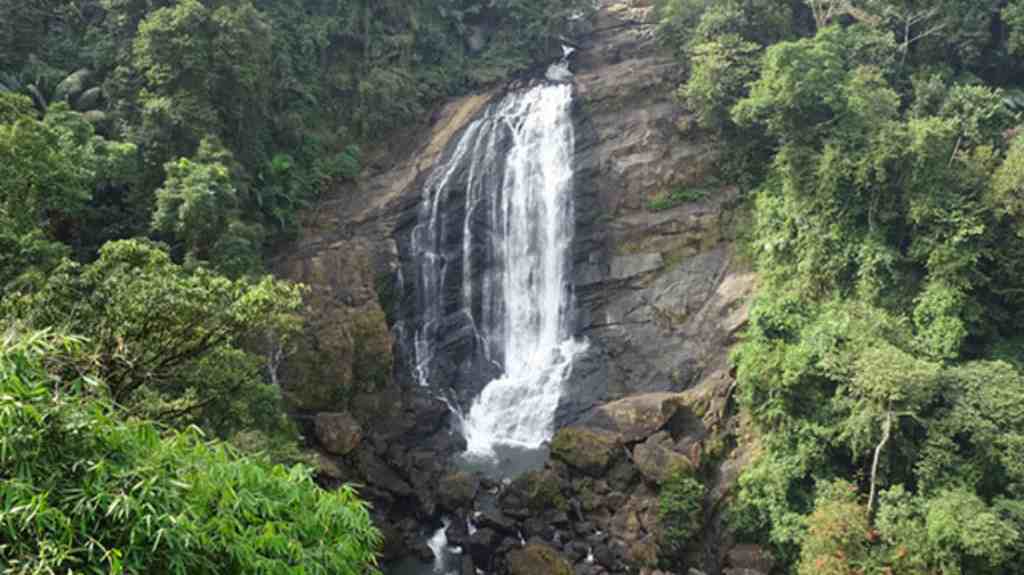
[{"xmin": 660, "ymin": 0, "xmax": 1024, "ymax": 574}]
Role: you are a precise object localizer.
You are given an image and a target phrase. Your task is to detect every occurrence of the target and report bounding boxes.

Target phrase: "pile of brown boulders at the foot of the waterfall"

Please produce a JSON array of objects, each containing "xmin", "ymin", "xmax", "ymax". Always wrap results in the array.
[{"xmin": 428, "ymin": 377, "xmax": 749, "ymax": 575}]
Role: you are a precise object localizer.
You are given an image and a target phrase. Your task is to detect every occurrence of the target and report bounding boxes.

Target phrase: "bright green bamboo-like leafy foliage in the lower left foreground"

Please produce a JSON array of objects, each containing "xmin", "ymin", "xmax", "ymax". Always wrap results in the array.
[{"xmin": 0, "ymin": 330, "xmax": 380, "ymax": 575}]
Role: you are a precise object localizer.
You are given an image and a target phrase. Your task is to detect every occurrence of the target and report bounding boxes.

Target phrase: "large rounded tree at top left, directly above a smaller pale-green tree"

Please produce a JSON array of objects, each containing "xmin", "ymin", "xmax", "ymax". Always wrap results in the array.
[{"xmin": 132, "ymin": 0, "xmax": 272, "ymax": 162}]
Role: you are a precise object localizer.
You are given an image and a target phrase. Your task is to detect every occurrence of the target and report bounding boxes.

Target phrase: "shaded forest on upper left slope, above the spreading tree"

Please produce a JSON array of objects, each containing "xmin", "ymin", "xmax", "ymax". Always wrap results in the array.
[{"xmin": 0, "ymin": 0, "xmax": 588, "ymax": 275}]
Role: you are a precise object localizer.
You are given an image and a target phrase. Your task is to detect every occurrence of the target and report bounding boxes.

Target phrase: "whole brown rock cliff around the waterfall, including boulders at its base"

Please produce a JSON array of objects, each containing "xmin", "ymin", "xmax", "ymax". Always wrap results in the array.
[{"xmin": 275, "ymin": 0, "xmax": 755, "ymax": 575}]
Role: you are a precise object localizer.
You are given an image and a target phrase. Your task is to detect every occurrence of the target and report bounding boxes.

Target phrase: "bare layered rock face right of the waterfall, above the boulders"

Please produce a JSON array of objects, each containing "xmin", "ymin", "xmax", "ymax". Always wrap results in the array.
[{"xmin": 560, "ymin": 0, "xmax": 753, "ymax": 423}]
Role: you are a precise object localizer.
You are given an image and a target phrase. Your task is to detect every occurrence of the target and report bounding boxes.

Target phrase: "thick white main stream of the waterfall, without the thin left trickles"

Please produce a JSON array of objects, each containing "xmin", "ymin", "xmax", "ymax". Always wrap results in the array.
[{"xmin": 464, "ymin": 84, "xmax": 583, "ymax": 455}]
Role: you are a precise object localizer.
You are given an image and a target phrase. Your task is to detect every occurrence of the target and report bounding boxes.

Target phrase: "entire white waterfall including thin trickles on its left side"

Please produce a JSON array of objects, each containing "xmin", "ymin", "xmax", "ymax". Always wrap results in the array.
[{"xmin": 412, "ymin": 76, "xmax": 585, "ymax": 455}]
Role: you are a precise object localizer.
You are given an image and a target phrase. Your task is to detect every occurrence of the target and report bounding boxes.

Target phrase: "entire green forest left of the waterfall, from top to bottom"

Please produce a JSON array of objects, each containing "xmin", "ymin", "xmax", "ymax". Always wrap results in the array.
[{"xmin": 0, "ymin": 0, "xmax": 589, "ymax": 575}]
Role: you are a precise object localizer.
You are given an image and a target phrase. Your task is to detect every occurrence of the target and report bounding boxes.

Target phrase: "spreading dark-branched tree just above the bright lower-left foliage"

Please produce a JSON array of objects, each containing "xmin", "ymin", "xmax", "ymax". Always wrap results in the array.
[{"xmin": 5, "ymin": 240, "xmax": 301, "ymax": 437}]
